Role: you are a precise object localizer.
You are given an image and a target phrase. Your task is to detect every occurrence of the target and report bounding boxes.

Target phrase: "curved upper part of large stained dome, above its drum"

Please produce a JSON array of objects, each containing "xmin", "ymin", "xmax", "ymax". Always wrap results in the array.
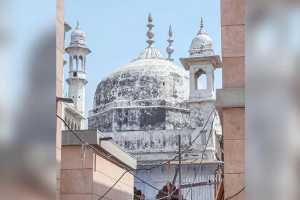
[{"xmin": 94, "ymin": 47, "xmax": 188, "ymax": 108}]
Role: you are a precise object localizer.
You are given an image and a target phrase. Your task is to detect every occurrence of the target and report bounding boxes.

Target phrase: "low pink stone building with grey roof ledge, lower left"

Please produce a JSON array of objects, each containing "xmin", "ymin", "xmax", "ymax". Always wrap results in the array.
[{"xmin": 61, "ymin": 130, "xmax": 136, "ymax": 200}]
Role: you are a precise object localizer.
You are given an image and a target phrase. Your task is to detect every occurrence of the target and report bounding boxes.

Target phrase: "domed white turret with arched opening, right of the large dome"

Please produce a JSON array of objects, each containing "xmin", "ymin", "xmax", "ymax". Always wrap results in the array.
[{"xmin": 180, "ymin": 18, "xmax": 221, "ymax": 102}]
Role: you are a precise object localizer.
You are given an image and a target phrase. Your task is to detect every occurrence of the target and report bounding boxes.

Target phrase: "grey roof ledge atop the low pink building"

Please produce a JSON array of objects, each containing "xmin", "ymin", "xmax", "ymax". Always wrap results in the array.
[{"xmin": 62, "ymin": 130, "xmax": 137, "ymax": 169}]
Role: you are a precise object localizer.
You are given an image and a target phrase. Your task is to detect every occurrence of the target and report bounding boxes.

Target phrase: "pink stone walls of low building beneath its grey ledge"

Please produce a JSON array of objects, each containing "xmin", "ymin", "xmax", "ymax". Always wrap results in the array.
[{"xmin": 61, "ymin": 146, "xmax": 134, "ymax": 200}]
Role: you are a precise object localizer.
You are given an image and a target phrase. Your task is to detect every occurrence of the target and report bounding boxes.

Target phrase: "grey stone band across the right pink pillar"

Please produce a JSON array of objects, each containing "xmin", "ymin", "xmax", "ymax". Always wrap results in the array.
[{"xmin": 216, "ymin": 88, "xmax": 245, "ymax": 108}]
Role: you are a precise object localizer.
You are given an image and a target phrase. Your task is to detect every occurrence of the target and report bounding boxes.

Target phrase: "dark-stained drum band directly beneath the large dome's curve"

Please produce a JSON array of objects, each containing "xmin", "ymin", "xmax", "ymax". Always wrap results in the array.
[{"xmin": 89, "ymin": 106, "xmax": 189, "ymax": 132}]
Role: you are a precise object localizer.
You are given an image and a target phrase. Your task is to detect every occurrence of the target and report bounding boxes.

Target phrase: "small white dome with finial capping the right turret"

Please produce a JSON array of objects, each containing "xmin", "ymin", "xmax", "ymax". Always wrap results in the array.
[{"xmin": 189, "ymin": 18, "xmax": 214, "ymax": 57}]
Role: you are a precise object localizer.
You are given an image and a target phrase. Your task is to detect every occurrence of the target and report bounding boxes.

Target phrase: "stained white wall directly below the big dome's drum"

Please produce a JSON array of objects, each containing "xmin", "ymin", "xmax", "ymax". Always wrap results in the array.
[{"xmin": 104, "ymin": 121, "xmax": 219, "ymax": 165}]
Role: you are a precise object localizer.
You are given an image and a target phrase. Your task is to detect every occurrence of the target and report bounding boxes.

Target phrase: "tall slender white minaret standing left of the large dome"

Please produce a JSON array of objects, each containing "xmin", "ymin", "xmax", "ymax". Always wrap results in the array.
[{"xmin": 66, "ymin": 22, "xmax": 91, "ymax": 114}]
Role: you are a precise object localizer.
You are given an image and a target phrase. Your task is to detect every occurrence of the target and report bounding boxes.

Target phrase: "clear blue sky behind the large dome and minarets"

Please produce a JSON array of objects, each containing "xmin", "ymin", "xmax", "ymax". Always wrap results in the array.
[{"xmin": 65, "ymin": 0, "xmax": 222, "ymax": 115}]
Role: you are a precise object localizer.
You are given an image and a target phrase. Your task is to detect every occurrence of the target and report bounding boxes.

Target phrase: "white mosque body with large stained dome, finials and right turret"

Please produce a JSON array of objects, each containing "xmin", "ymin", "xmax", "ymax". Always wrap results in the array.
[{"xmin": 88, "ymin": 15, "xmax": 222, "ymax": 200}]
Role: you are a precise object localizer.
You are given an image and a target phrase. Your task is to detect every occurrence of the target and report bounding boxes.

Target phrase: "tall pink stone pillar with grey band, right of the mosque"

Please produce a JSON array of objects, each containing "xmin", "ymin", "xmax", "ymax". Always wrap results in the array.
[{"xmin": 217, "ymin": 0, "xmax": 245, "ymax": 200}]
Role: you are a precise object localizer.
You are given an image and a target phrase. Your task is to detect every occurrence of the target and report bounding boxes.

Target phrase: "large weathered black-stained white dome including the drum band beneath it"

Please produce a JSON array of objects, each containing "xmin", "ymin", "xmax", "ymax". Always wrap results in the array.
[{"xmin": 89, "ymin": 47, "xmax": 189, "ymax": 131}]
